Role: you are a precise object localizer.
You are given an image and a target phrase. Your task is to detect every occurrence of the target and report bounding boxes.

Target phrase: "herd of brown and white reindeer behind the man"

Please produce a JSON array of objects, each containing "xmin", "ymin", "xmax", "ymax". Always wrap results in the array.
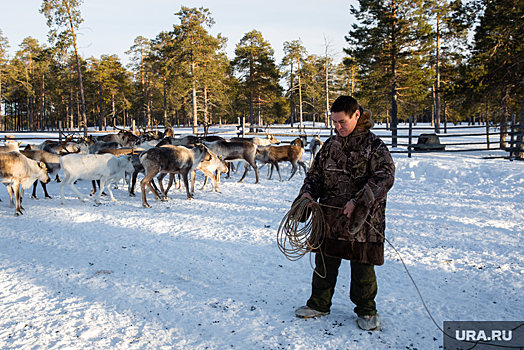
[{"xmin": 0, "ymin": 129, "xmax": 322, "ymax": 216}]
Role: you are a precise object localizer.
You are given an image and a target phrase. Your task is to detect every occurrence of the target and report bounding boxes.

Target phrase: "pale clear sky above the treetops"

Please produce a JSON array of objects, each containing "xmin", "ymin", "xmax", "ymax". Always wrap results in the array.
[{"xmin": 0, "ymin": 0, "xmax": 358, "ymax": 63}]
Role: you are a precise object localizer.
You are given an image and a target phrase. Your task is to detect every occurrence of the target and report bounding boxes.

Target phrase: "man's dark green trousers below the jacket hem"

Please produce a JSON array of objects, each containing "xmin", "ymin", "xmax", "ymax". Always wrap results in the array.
[{"xmin": 307, "ymin": 253, "xmax": 377, "ymax": 316}]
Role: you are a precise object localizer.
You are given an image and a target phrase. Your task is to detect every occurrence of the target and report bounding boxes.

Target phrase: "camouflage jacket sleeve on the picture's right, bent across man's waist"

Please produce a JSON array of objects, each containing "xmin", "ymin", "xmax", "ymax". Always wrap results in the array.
[{"xmin": 353, "ymin": 139, "xmax": 395, "ymax": 209}]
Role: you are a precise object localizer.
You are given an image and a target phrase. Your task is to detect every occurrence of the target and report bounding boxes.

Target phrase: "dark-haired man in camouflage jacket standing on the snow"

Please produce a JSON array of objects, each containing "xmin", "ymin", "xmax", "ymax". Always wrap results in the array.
[{"xmin": 295, "ymin": 96, "xmax": 395, "ymax": 330}]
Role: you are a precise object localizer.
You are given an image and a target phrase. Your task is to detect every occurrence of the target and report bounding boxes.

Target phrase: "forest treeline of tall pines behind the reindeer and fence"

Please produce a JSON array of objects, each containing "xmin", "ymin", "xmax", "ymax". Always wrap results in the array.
[{"xmin": 0, "ymin": 0, "xmax": 524, "ymax": 132}]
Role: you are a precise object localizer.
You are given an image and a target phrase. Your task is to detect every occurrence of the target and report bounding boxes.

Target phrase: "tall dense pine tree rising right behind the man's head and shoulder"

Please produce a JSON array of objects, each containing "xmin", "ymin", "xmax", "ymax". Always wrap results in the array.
[{"xmin": 345, "ymin": 0, "xmax": 431, "ymax": 147}]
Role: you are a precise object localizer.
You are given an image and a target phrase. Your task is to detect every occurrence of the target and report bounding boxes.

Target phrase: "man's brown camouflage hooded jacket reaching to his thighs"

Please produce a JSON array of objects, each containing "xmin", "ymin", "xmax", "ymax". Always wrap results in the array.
[{"xmin": 299, "ymin": 110, "xmax": 395, "ymax": 265}]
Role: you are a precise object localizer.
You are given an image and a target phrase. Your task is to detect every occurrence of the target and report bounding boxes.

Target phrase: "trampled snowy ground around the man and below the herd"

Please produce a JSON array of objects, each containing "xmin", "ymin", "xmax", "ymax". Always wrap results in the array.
[{"xmin": 0, "ymin": 127, "xmax": 524, "ymax": 350}]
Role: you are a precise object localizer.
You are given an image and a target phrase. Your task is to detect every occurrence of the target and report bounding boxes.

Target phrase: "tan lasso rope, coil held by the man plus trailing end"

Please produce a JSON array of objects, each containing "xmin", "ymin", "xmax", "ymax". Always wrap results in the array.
[{"xmin": 277, "ymin": 198, "xmax": 524, "ymax": 349}]
